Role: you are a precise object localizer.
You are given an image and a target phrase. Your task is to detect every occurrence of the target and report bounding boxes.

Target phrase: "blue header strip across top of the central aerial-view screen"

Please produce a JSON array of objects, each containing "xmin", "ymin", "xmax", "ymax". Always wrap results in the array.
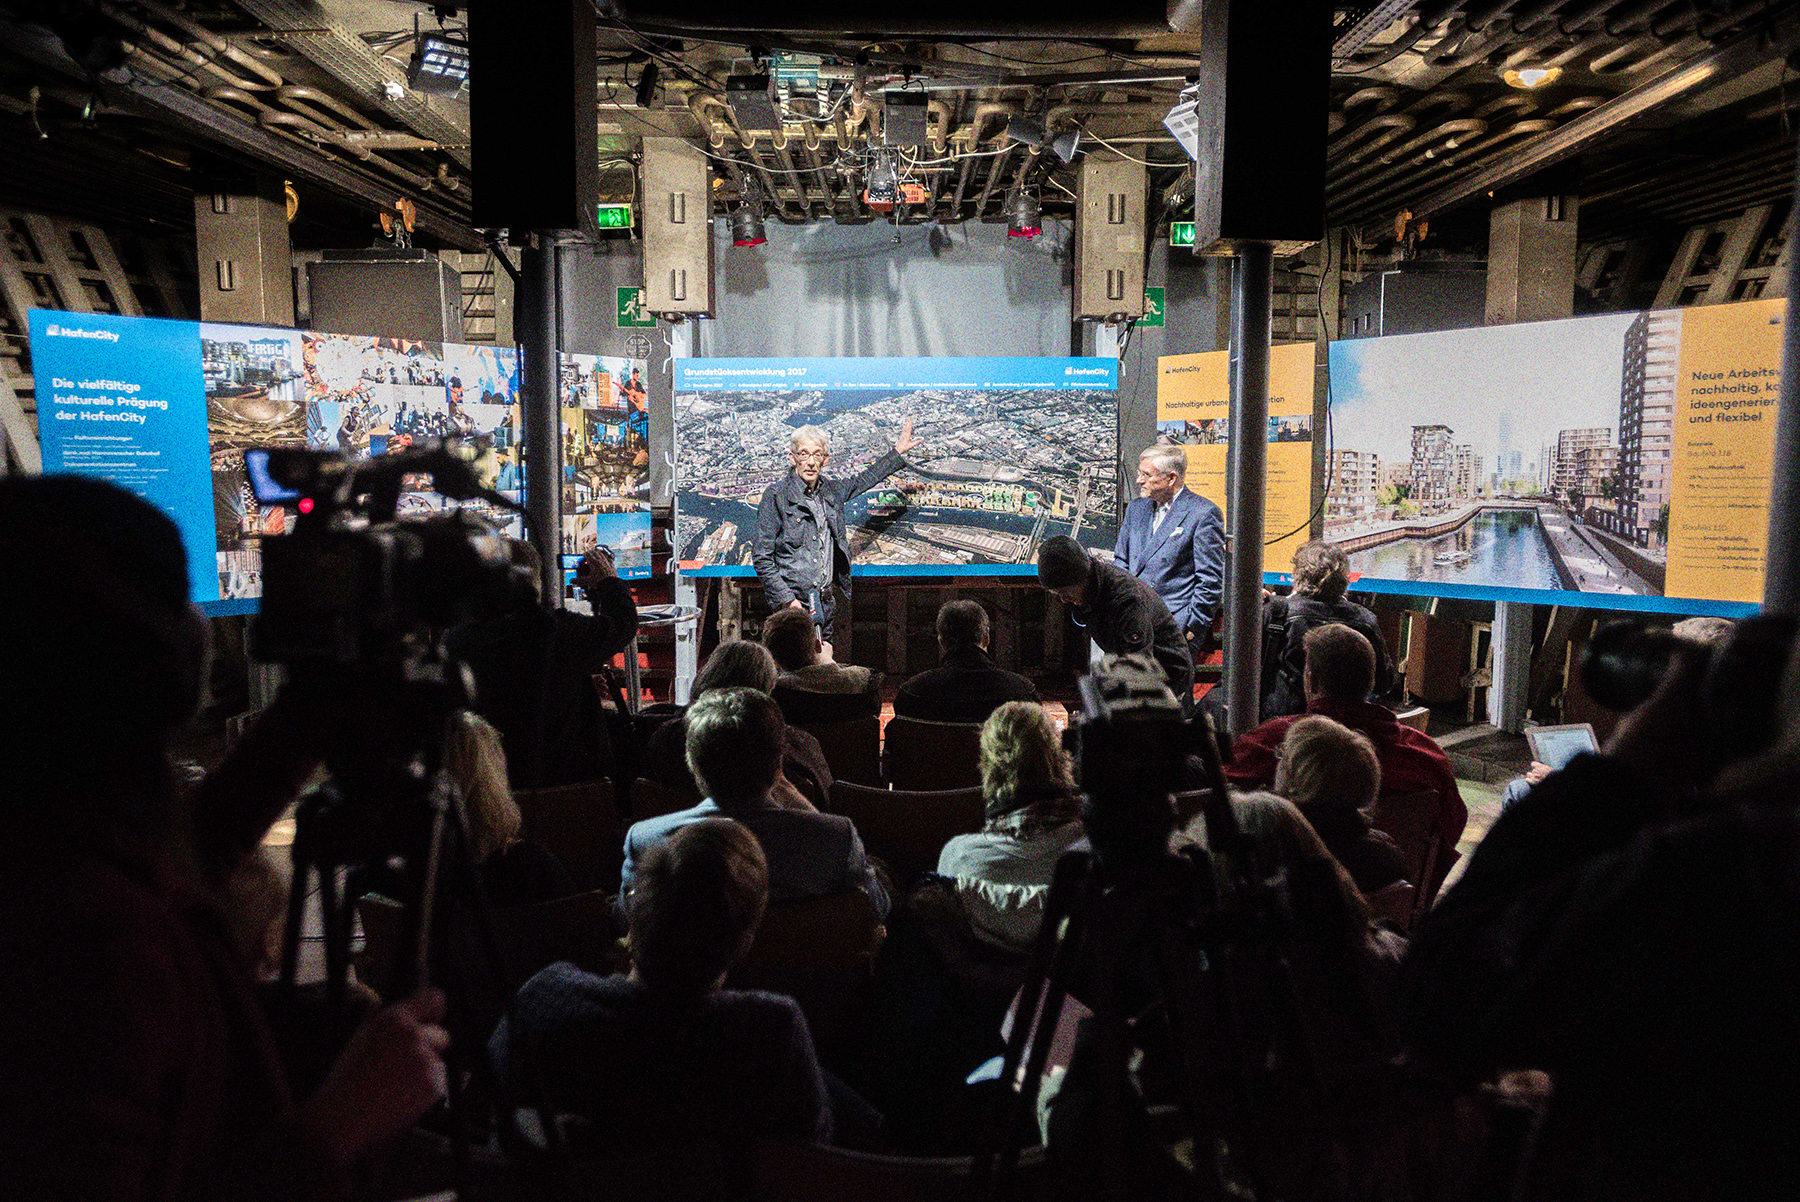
[{"xmin": 675, "ymin": 356, "xmax": 1120, "ymax": 392}]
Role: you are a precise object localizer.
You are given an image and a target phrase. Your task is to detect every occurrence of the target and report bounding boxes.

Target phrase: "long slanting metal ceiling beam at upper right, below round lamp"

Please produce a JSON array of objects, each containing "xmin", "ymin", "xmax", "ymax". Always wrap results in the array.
[{"xmin": 1406, "ymin": 4, "xmax": 1796, "ymax": 218}]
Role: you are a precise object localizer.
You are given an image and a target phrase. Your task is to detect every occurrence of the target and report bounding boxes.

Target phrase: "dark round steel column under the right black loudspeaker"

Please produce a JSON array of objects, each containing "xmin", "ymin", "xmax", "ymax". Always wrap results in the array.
[{"xmin": 1224, "ymin": 241, "xmax": 1274, "ymax": 736}]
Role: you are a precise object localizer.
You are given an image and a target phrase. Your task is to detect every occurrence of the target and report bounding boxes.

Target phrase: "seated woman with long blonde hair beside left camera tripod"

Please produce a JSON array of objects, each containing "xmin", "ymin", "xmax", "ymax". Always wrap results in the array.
[{"xmin": 445, "ymin": 711, "xmax": 576, "ymax": 905}]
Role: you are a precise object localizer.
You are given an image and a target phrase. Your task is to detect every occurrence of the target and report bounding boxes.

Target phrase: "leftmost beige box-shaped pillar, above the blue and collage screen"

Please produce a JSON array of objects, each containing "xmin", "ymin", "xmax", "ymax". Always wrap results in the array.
[{"xmin": 194, "ymin": 180, "xmax": 293, "ymax": 326}]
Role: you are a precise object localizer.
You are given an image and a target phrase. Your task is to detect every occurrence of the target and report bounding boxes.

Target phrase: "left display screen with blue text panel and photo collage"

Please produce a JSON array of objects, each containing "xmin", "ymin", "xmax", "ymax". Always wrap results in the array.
[{"xmin": 31, "ymin": 309, "xmax": 650, "ymax": 614}]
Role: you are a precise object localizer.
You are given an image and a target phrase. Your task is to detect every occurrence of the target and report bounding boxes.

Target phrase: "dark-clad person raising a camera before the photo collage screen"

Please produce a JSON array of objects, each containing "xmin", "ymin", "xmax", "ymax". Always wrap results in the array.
[{"xmin": 445, "ymin": 540, "xmax": 637, "ymax": 790}]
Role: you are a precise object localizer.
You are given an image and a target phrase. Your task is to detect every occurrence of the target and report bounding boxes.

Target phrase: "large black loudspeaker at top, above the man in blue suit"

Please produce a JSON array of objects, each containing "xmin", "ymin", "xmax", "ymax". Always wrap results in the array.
[{"xmin": 1193, "ymin": 0, "xmax": 1332, "ymax": 250}]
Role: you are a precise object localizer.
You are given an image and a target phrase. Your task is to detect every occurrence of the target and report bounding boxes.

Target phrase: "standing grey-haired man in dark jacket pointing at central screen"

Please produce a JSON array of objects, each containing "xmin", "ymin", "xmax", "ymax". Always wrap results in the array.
[{"xmin": 752, "ymin": 419, "xmax": 918, "ymax": 642}]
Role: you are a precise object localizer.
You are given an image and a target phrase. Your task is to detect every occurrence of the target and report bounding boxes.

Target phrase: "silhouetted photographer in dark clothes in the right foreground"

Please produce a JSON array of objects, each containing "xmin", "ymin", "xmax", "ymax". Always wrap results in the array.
[{"xmin": 1404, "ymin": 619, "xmax": 1800, "ymax": 1200}]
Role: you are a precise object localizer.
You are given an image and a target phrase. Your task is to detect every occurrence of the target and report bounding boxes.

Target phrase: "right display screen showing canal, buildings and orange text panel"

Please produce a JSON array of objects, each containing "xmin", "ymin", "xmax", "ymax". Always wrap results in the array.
[{"xmin": 1325, "ymin": 301, "xmax": 1786, "ymax": 614}]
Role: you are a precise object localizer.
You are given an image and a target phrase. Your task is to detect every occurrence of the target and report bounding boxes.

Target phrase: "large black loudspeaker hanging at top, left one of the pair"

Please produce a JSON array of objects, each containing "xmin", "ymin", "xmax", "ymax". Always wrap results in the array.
[{"xmin": 468, "ymin": 0, "xmax": 599, "ymax": 234}]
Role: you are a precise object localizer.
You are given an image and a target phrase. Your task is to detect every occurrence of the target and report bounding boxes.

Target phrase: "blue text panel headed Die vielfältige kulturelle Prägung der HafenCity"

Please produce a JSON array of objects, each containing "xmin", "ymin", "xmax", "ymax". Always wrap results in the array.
[{"xmin": 31, "ymin": 309, "xmax": 221, "ymax": 608}]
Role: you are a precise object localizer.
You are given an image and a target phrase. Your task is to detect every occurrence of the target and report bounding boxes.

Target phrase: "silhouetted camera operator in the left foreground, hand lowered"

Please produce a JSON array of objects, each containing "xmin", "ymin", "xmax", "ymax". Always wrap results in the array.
[{"xmin": 0, "ymin": 477, "xmax": 446, "ymax": 1202}]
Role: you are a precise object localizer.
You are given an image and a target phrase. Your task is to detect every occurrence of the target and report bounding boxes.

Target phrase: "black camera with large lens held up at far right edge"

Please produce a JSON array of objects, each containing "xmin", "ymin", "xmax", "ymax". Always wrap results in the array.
[{"xmin": 1582, "ymin": 614, "xmax": 1796, "ymax": 763}]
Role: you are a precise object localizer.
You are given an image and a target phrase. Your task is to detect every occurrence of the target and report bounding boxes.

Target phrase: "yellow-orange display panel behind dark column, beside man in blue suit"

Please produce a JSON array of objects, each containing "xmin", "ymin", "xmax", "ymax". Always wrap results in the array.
[{"xmin": 1156, "ymin": 342, "xmax": 1314, "ymax": 576}]
